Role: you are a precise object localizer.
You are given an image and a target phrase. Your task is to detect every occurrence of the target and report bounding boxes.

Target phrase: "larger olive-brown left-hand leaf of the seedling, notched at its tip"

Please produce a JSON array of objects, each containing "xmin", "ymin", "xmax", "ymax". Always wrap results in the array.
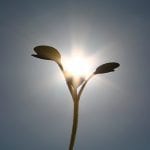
[{"xmin": 32, "ymin": 45, "xmax": 61, "ymax": 64}]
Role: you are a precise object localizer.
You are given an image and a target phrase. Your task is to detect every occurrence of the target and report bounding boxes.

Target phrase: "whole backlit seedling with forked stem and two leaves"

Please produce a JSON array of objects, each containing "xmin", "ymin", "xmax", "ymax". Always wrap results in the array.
[{"xmin": 32, "ymin": 45, "xmax": 120, "ymax": 150}]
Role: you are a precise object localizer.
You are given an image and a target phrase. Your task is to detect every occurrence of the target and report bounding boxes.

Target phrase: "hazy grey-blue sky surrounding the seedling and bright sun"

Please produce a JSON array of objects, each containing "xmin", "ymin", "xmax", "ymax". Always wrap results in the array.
[{"xmin": 0, "ymin": 0, "xmax": 150, "ymax": 150}]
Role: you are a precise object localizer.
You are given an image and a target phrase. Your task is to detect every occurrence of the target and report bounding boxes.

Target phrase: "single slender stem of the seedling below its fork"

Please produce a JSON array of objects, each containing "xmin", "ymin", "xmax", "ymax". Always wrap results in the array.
[{"xmin": 69, "ymin": 100, "xmax": 79, "ymax": 150}]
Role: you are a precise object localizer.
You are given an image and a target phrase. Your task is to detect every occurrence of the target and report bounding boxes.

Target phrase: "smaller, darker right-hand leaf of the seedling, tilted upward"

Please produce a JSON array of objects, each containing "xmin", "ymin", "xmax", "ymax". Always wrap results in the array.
[{"xmin": 94, "ymin": 62, "xmax": 120, "ymax": 74}]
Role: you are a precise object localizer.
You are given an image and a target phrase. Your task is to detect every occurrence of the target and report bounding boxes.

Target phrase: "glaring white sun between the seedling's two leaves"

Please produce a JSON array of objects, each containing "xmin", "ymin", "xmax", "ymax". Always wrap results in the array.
[{"xmin": 63, "ymin": 51, "xmax": 91, "ymax": 77}]
